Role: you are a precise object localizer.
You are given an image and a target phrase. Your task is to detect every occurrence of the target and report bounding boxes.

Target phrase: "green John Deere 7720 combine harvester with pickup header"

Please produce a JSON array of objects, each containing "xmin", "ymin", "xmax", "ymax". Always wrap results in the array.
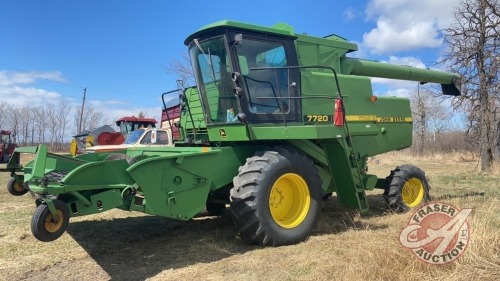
[{"xmin": 8, "ymin": 21, "xmax": 460, "ymax": 246}]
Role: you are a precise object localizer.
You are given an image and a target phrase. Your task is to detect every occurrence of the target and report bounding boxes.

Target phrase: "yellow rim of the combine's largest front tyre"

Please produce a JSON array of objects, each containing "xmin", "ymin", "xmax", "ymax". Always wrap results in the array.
[{"xmin": 269, "ymin": 173, "xmax": 311, "ymax": 228}]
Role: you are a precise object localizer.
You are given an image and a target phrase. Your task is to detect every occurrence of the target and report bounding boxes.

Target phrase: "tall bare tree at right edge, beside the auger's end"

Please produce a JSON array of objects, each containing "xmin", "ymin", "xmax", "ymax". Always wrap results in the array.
[{"xmin": 443, "ymin": 0, "xmax": 500, "ymax": 172}]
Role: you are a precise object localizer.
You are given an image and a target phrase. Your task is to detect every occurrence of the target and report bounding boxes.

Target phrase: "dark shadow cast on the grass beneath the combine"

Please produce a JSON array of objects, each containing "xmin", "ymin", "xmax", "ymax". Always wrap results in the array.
[{"xmin": 67, "ymin": 196, "xmax": 392, "ymax": 280}]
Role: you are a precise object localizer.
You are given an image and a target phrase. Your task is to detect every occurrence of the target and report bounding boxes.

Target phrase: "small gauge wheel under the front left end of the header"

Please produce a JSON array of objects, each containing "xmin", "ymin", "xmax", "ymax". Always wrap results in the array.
[{"xmin": 31, "ymin": 199, "xmax": 69, "ymax": 242}]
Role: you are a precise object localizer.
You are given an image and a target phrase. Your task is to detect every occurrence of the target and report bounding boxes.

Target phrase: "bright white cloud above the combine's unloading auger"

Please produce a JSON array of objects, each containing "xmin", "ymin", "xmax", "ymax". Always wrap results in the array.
[{"xmin": 363, "ymin": 0, "xmax": 457, "ymax": 54}]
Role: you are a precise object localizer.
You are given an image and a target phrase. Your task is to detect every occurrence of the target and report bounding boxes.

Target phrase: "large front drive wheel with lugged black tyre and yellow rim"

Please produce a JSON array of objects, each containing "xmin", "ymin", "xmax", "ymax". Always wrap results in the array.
[{"xmin": 231, "ymin": 147, "xmax": 322, "ymax": 246}]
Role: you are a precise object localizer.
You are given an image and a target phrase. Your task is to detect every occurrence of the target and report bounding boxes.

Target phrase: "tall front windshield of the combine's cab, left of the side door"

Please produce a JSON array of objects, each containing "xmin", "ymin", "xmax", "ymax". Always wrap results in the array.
[{"xmin": 189, "ymin": 36, "xmax": 238, "ymax": 123}]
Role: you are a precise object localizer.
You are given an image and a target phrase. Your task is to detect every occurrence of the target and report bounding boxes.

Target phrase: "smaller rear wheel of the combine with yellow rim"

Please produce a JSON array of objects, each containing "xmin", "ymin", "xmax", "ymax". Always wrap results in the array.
[{"xmin": 384, "ymin": 165, "xmax": 430, "ymax": 213}]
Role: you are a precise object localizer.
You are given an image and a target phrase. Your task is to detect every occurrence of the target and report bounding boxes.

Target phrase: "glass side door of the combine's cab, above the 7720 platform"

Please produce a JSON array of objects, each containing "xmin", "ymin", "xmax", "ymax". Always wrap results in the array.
[{"xmin": 230, "ymin": 33, "xmax": 301, "ymax": 123}]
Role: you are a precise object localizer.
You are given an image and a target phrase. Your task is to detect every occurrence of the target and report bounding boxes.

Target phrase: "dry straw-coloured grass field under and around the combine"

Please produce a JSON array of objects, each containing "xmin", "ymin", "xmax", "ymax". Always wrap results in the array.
[{"xmin": 0, "ymin": 152, "xmax": 500, "ymax": 281}]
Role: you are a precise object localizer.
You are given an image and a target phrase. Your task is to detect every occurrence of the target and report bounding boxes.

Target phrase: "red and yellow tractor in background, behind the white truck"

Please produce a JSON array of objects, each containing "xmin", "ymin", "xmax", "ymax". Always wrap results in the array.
[{"xmin": 70, "ymin": 116, "xmax": 158, "ymax": 156}]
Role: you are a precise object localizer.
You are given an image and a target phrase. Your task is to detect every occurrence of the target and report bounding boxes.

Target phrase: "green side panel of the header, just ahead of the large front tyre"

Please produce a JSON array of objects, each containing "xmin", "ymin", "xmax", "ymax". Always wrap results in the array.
[{"xmin": 127, "ymin": 146, "xmax": 259, "ymax": 220}]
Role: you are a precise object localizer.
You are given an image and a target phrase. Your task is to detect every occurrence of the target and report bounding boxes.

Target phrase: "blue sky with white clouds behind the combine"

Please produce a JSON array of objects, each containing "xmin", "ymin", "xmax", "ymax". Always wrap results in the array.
[{"xmin": 0, "ymin": 0, "xmax": 459, "ymax": 131}]
